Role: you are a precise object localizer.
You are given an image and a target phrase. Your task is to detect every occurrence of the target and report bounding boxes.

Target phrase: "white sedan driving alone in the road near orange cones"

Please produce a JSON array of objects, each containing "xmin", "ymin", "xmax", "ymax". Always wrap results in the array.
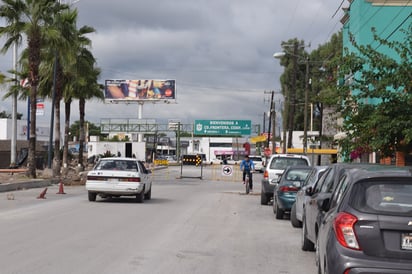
[{"xmin": 86, "ymin": 157, "xmax": 152, "ymax": 203}]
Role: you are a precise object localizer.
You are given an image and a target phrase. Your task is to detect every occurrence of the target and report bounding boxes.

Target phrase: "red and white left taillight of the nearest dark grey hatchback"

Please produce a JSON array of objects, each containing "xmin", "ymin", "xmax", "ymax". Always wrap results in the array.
[{"xmin": 333, "ymin": 212, "xmax": 361, "ymax": 250}]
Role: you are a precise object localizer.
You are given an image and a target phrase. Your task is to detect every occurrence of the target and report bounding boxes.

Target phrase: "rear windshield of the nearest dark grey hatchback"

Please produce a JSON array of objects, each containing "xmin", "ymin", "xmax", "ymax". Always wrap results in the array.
[{"xmin": 351, "ymin": 181, "xmax": 412, "ymax": 216}]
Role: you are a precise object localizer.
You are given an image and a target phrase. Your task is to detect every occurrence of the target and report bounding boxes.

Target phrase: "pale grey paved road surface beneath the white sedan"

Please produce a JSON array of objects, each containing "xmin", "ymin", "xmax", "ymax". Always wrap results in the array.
[{"xmin": 0, "ymin": 165, "xmax": 316, "ymax": 274}]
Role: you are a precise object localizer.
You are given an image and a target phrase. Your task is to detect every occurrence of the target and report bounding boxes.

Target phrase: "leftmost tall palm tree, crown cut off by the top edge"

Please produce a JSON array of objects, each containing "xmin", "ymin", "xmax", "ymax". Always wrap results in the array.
[{"xmin": 0, "ymin": 0, "xmax": 67, "ymax": 178}]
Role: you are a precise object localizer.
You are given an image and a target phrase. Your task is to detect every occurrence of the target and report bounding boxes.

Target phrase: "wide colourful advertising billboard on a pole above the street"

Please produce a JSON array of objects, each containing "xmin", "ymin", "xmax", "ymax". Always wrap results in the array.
[{"xmin": 104, "ymin": 80, "xmax": 176, "ymax": 101}]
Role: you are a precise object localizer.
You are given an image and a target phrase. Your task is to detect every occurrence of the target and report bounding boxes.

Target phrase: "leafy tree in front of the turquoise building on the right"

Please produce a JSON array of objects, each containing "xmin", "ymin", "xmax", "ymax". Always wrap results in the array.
[{"xmin": 339, "ymin": 26, "xmax": 412, "ymax": 161}]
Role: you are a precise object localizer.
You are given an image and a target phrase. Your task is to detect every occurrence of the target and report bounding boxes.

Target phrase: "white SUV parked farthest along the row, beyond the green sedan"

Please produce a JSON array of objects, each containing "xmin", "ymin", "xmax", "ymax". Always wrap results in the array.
[{"xmin": 260, "ymin": 154, "xmax": 310, "ymax": 205}]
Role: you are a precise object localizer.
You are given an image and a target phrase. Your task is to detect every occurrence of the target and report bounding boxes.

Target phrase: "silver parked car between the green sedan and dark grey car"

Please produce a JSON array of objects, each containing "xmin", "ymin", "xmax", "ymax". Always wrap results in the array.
[{"xmin": 290, "ymin": 166, "xmax": 327, "ymax": 227}]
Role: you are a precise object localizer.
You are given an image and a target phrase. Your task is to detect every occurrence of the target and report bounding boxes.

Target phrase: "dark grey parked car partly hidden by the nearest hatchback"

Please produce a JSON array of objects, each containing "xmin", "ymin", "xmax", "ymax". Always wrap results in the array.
[{"xmin": 301, "ymin": 163, "xmax": 360, "ymax": 251}]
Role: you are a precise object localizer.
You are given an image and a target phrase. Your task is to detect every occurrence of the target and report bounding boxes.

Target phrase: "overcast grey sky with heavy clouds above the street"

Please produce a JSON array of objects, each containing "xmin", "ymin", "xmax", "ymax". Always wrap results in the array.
[{"xmin": 0, "ymin": 0, "xmax": 347, "ymax": 132}]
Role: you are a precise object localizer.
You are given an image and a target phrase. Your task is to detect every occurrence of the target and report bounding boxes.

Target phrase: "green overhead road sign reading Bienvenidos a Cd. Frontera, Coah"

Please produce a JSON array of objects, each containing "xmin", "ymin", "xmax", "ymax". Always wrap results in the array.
[{"xmin": 193, "ymin": 120, "xmax": 252, "ymax": 135}]
